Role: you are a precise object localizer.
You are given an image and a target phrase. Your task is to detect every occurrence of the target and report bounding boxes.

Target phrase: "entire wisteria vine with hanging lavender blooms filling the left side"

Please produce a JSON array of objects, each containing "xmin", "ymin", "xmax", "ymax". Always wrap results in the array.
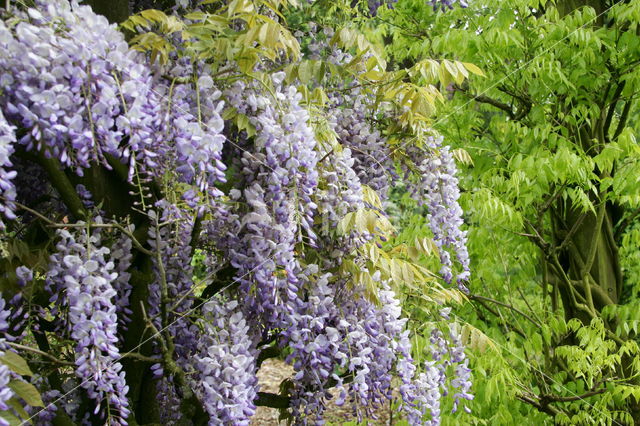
[{"xmin": 0, "ymin": 0, "xmax": 472, "ymax": 425}]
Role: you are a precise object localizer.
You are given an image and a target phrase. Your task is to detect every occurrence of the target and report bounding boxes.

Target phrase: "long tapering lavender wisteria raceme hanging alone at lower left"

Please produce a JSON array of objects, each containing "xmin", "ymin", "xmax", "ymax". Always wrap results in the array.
[{"xmin": 47, "ymin": 221, "xmax": 129, "ymax": 425}]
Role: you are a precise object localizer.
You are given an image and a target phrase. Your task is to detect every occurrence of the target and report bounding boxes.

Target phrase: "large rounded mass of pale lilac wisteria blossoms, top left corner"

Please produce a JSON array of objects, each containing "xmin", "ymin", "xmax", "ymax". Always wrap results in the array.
[{"xmin": 0, "ymin": 0, "xmax": 157, "ymax": 175}]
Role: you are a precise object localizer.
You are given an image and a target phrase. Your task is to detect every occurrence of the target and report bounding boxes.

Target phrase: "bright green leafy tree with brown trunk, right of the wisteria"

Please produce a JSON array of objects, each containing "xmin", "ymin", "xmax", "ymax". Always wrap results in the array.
[{"xmin": 378, "ymin": 1, "xmax": 640, "ymax": 424}]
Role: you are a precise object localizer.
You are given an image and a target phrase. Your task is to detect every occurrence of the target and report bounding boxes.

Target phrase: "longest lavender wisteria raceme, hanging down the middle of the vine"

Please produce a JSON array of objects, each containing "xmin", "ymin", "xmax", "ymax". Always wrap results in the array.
[{"xmin": 227, "ymin": 73, "xmax": 318, "ymax": 329}]
